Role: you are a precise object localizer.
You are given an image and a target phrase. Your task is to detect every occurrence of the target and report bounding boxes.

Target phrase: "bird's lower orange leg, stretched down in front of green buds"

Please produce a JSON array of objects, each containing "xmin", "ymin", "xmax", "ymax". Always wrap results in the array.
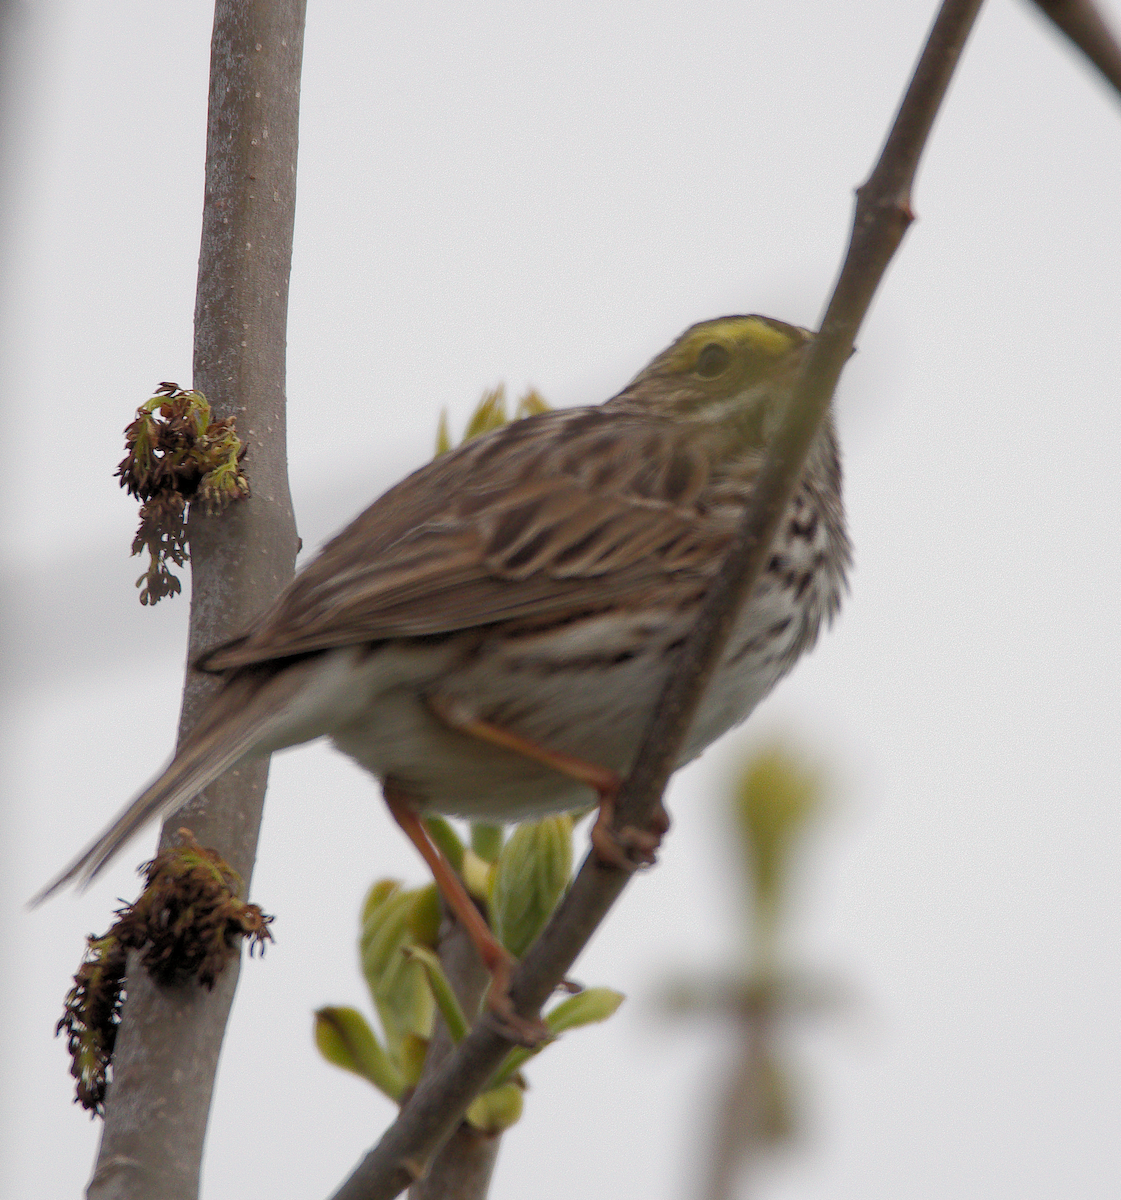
[{"xmin": 382, "ymin": 779, "xmax": 548, "ymax": 1046}]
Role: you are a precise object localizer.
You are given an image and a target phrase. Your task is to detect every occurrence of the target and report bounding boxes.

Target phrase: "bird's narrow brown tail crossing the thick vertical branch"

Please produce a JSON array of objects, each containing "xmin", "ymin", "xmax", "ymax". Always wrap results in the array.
[{"xmin": 30, "ymin": 668, "xmax": 301, "ymax": 907}]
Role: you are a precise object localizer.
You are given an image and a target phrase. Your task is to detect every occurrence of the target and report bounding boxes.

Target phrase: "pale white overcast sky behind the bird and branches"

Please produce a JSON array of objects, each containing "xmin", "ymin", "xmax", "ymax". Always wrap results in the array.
[{"xmin": 0, "ymin": 0, "xmax": 1121, "ymax": 1200}]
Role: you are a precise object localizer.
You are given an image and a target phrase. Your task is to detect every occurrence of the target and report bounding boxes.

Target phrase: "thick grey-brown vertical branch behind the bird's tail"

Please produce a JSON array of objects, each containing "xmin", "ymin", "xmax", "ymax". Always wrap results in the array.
[{"xmin": 88, "ymin": 0, "xmax": 305, "ymax": 1200}]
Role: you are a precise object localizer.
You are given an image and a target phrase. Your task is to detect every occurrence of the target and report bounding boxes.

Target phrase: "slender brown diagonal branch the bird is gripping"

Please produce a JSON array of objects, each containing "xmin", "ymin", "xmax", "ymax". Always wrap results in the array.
[{"xmin": 334, "ymin": 0, "xmax": 981, "ymax": 1200}]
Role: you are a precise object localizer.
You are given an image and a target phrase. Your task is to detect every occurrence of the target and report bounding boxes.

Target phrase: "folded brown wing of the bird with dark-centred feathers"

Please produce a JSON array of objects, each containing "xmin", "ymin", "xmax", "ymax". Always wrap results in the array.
[{"xmin": 198, "ymin": 408, "xmax": 735, "ymax": 671}]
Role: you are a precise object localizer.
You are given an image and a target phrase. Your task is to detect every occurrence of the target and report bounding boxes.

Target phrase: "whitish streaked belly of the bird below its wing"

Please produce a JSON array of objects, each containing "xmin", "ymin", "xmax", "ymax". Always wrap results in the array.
[{"xmin": 328, "ymin": 556, "xmax": 835, "ymax": 821}]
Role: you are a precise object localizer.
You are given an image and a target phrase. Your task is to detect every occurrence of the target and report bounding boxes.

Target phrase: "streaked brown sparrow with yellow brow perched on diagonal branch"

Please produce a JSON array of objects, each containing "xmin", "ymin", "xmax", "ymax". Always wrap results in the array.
[{"xmin": 35, "ymin": 314, "xmax": 851, "ymax": 1008}]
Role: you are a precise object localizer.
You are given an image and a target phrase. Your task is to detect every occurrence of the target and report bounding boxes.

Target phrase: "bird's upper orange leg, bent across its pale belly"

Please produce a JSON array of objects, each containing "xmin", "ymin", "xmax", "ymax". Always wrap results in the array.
[{"xmin": 428, "ymin": 697, "xmax": 670, "ymax": 871}]
